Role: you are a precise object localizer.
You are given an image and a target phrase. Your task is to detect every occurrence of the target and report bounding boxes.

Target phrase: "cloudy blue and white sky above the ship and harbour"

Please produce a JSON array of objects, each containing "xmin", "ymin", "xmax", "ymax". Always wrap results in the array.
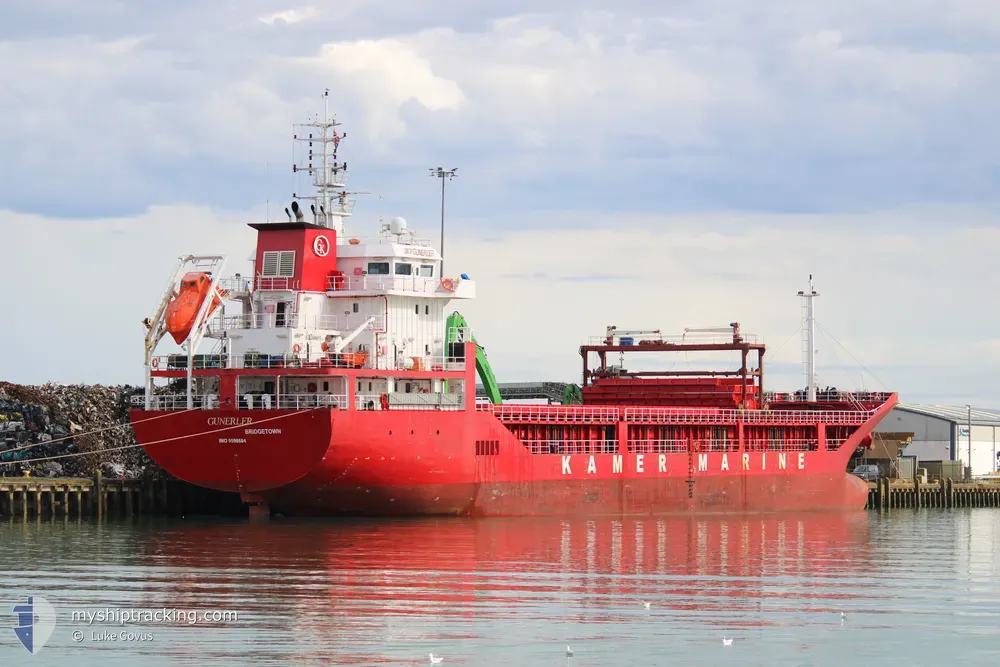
[{"xmin": 0, "ymin": 0, "xmax": 1000, "ymax": 408}]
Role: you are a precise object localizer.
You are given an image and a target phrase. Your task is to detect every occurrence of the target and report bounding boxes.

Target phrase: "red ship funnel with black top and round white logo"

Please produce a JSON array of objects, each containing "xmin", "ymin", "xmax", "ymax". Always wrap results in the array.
[{"xmin": 250, "ymin": 222, "xmax": 337, "ymax": 292}]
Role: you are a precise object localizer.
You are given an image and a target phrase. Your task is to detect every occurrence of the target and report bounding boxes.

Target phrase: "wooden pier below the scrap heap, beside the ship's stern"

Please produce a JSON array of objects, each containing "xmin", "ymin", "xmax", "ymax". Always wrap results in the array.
[{"xmin": 0, "ymin": 473, "xmax": 246, "ymax": 520}]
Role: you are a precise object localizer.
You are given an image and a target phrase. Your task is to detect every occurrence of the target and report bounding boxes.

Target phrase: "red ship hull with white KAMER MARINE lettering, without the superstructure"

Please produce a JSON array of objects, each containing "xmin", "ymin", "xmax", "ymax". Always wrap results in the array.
[{"xmin": 133, "ymin": 400, "xmax": 895, "ymax": 516}]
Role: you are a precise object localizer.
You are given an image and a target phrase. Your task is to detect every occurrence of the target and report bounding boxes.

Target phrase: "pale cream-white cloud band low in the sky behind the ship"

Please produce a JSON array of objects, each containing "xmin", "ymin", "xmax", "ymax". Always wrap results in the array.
[{"xmin": 0, "ymin": 201, "xmax": 1000, "ymax": 406}]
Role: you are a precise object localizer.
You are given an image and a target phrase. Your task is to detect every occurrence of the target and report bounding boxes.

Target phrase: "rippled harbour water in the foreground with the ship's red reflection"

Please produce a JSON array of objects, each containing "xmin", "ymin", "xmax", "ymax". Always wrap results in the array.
[{"xmin": 0, "ymin": 510, "xmax": 1000, "ymax": 666}]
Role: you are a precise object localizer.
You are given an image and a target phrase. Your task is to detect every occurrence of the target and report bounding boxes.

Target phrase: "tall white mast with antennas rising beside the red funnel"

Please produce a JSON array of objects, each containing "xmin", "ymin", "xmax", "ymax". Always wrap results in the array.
[{"xmin": 292, "ymin": 88, "xmax": 367, "ymax": 243}]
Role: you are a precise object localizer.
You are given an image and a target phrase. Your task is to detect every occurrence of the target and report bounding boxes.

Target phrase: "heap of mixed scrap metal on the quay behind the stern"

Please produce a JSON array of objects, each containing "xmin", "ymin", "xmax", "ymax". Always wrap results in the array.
[{"xmin": 0, "ymin": 382, "xmax": 160, "ymax": 478}]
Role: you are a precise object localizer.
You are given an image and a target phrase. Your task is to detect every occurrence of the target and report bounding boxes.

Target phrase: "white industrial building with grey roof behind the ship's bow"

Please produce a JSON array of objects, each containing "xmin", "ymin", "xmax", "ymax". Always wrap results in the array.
[{"xmin": 875, "ymin": 403, "xmax": 1000, "ymax": 476}]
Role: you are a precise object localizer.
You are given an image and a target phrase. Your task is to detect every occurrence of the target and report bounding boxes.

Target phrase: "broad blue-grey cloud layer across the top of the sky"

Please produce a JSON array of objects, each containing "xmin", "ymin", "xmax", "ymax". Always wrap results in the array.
[{"xmin": 0, "ymin": 0, "xmax": 1000, "ymax": 217}]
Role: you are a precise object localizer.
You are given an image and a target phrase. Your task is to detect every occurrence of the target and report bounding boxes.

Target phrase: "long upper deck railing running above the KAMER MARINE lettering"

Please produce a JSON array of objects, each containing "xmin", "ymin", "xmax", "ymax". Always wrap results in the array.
[{"xmin": 476, "ymin": 402, "xmax": 875, "ymax": 426}]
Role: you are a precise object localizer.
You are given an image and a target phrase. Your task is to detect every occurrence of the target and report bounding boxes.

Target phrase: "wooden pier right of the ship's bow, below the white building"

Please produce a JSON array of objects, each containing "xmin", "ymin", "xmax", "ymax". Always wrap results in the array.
[{"xmin": 867, "ymin": 478, "xmax": 1000, "ymax": 510}]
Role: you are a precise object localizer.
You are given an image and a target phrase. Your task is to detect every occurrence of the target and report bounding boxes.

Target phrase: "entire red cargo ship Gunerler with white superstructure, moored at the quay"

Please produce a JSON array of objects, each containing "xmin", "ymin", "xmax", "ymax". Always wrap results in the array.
[{"xmin": 131, "ymin": 94, "xmax": 897, "ymax": 516}]
